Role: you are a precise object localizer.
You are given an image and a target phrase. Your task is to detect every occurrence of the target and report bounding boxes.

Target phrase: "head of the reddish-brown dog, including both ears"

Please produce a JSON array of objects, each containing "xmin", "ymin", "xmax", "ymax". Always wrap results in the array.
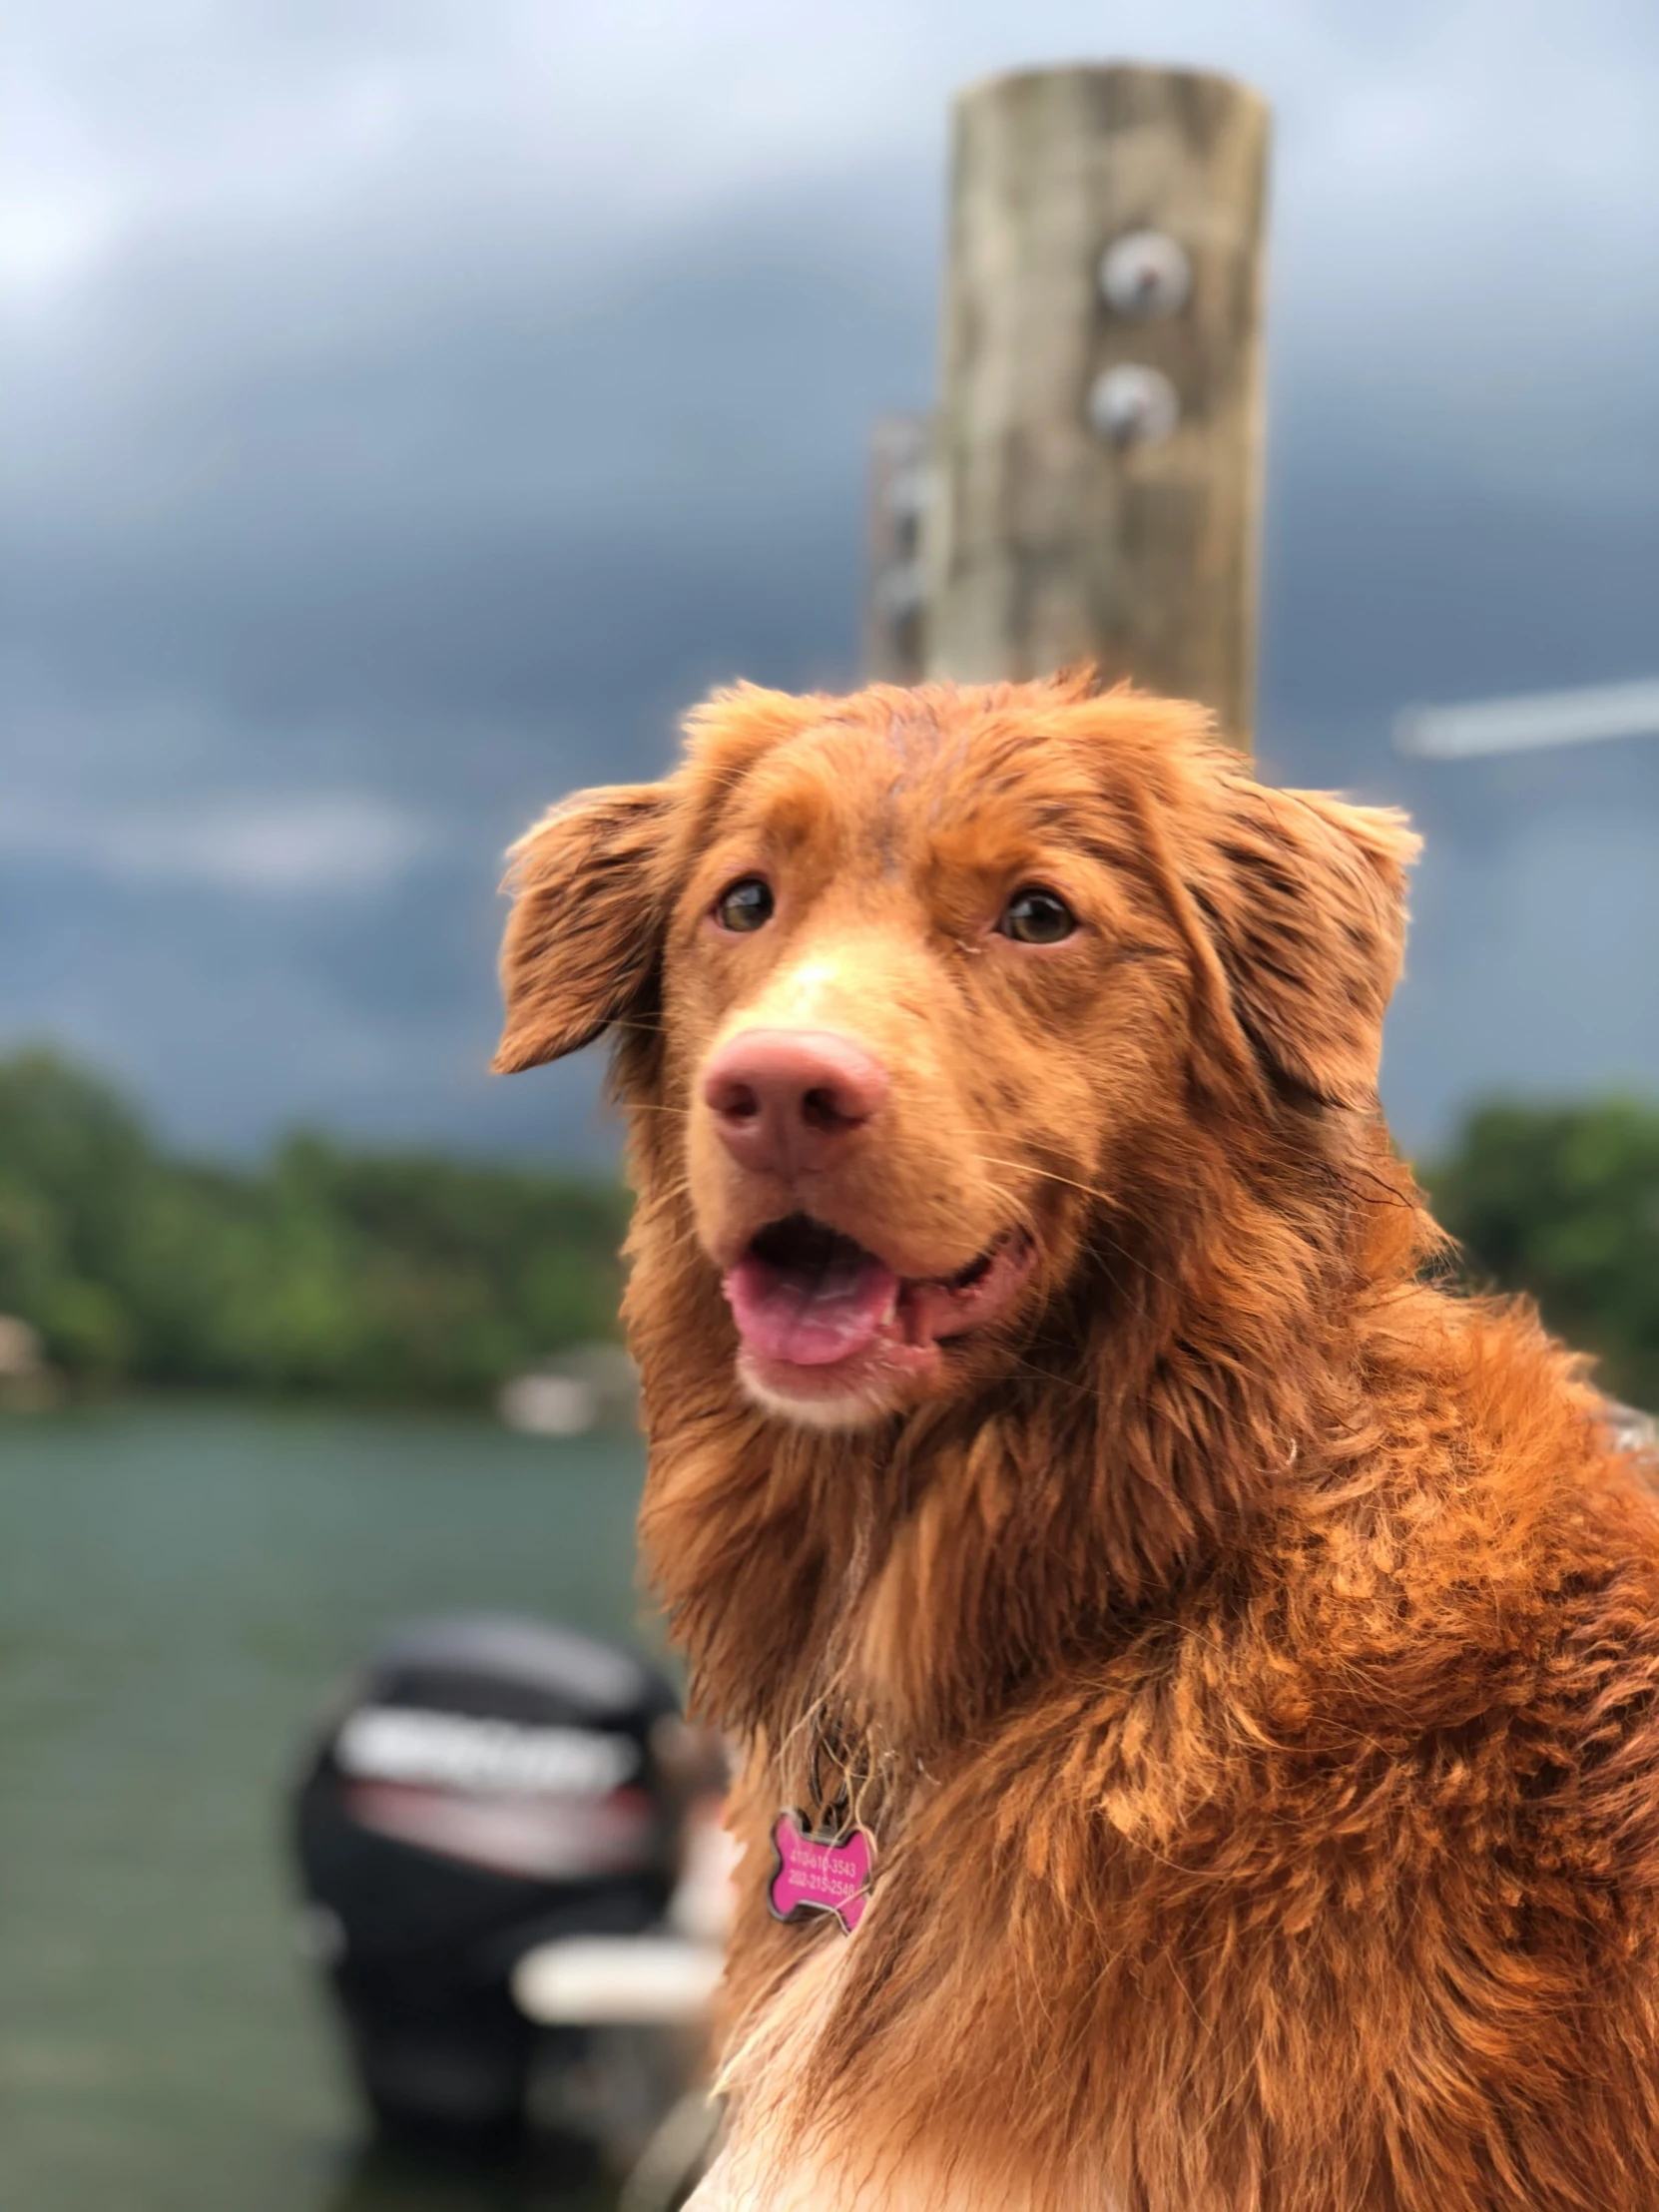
[{"xmin": 498, "ymin": 679, "xmax": 1415, "ymax": 1426}]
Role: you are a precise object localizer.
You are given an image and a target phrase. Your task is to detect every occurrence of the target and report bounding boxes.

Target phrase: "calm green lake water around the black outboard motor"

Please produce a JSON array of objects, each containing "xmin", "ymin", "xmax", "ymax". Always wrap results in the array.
[{"xmin": 0, "ymin": 1404, "xmax": 659, "ymax": 2212}]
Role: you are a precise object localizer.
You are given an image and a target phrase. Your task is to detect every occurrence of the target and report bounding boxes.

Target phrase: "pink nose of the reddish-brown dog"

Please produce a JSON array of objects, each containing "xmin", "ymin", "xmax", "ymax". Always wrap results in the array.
[{"xmin": 704, "ymin": 1028, "xmax": 887, "ymax": 1175}]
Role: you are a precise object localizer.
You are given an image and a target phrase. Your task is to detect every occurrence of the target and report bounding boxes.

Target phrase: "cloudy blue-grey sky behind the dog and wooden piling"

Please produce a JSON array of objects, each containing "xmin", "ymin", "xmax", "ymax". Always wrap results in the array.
[{"xmin": 0, "ymin": 0, "xmax": 1659, "ymax": 1153}]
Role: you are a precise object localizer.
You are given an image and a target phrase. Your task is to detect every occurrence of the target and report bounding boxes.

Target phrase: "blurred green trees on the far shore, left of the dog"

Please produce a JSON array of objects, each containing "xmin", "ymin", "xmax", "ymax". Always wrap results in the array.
[{"xmin": 0, "ymin": 1053, "xmax": 628, "ymax": 1402}]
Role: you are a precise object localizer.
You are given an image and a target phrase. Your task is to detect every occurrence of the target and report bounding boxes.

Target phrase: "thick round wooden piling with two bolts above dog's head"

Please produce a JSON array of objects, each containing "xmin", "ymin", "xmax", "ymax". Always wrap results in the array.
[{"xmin": 924, "ymin": 66, "xmax": 1270, "ymax": 746}]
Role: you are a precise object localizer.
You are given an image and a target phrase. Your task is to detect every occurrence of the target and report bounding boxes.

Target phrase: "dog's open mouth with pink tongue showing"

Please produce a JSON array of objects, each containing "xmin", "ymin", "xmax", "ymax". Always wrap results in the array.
[{"xmin": 724, "ymin": 1215, "xmax": 1035, "ymax": 1381}]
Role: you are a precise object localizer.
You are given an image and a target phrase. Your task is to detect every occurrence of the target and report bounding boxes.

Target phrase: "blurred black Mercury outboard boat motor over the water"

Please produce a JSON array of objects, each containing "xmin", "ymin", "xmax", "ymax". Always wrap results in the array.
[{"xmin": 296, "ymin": 1617, "xmax": 719, "ymax": 2168}]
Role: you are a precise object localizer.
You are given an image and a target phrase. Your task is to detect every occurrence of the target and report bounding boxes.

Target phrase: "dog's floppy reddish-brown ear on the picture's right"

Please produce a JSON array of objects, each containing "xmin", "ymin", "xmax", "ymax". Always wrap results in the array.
[{"xmin": 1204, "ymin": 777, "xmax": 1420, "ymax": 1108}]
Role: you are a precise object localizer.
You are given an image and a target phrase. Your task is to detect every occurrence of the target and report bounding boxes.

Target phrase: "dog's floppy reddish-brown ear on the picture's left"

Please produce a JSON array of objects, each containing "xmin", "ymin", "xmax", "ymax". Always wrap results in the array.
[{"xmin": 493, "ymin": 783, "xmax": 673, "ymax": 1075}]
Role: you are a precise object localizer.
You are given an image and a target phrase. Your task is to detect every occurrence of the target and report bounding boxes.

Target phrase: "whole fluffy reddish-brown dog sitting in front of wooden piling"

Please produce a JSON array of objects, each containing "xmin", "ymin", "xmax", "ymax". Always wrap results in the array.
[{"xmin": 500, "ymin": 682, "xmax": 1659, "ymax": 2212}]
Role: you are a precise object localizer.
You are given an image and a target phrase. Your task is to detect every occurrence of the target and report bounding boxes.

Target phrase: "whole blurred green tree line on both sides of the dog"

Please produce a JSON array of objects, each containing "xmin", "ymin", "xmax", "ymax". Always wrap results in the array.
[{"xmin": 0, "ymin": 1053, "xmax": 1659, "ymax": 1409}]
